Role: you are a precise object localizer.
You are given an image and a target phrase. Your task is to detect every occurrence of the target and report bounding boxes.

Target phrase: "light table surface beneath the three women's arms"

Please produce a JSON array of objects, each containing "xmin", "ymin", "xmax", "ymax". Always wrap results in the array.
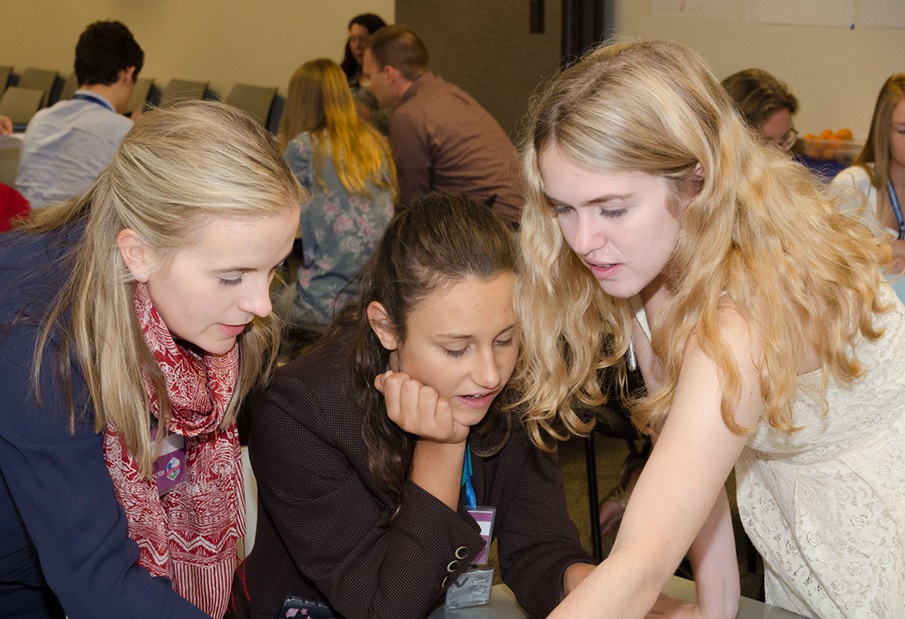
[{"xmin": 428, "ymin": 576, "xmax": 801, "ymax": 619}]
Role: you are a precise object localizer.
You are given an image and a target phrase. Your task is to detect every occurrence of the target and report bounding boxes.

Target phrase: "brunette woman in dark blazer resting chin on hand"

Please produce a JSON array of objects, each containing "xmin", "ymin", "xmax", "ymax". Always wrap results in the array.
[{"xmin": 234, "ymin": 194, "xmax": 594, "ymax": 619}]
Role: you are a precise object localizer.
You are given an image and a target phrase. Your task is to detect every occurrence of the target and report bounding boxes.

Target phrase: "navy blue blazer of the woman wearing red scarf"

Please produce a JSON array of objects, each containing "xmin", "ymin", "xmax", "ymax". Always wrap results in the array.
[{"xmin": 0, "ymin": 227, "xmax": 207, "ymax": 619}]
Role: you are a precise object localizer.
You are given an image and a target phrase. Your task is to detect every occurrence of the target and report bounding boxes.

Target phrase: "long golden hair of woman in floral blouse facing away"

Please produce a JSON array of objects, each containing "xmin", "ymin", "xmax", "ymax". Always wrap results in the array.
[{"xmin": 280, "ymin": 58, "xmax": 396, "ymax": 196}]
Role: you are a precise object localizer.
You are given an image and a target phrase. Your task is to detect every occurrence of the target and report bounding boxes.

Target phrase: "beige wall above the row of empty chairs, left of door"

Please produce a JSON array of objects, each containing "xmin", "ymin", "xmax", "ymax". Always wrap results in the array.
[{"xmin": 0, "ymin": 0, "xmax": 395, "ymax": 103}]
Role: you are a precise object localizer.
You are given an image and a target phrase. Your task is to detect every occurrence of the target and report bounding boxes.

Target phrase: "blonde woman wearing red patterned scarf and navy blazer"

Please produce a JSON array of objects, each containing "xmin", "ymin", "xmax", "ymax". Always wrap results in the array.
[{"xmin": 0, "ymin": 102, "xmax": 304, "ymax": 619}]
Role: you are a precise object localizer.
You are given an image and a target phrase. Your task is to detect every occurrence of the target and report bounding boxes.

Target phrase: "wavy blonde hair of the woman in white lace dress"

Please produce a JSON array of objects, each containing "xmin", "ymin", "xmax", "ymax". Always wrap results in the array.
[{"xmin": 516, "ymin": 41, "xmax": 890, "ymax": 445}]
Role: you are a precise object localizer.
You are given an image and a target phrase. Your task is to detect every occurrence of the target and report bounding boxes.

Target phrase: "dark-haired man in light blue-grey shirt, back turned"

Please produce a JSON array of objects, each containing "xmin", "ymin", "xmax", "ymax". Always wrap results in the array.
[{"xmin": 16, "ymin": 21, "xmax": 144, "ymax": 208}]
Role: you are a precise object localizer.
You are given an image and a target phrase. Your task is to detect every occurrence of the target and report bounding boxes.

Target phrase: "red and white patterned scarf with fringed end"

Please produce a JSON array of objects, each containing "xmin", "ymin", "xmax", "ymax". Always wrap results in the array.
[{"xmin": 104, "ymin": 283, "xmax": 245, "ymax": 618}]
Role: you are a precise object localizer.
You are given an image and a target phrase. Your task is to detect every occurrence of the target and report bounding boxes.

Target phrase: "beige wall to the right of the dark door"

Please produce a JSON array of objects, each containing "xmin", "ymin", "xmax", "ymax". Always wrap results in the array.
[{"xmin": 616, "ymin": 0, "xmax": 905, "ymax": 139}]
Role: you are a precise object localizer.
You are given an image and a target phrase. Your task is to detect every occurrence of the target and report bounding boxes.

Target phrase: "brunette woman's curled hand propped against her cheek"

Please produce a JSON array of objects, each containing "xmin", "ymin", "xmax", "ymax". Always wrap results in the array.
[{"xmin": 374, "ymin": 370, "xmax": 470, "ymax": 444}]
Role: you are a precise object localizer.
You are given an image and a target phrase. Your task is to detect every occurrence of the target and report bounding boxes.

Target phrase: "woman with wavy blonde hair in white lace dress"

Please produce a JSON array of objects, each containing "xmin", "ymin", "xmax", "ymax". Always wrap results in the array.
[{"xmin": 515, "ymin": 41, "xmax": 905, "ymax": 619}]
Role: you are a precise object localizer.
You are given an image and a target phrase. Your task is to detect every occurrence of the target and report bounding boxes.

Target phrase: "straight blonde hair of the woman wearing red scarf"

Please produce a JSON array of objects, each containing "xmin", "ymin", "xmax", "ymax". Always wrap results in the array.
[{"xmin": 24, "ymin": 102, "xmax": 306, "ymax": 475}]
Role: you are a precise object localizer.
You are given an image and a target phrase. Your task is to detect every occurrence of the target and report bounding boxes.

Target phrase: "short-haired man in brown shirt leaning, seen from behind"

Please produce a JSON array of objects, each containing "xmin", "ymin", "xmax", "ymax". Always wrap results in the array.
[{"xmin": 362, "ymin": 26, "xmax": 523, "ymax": 227}]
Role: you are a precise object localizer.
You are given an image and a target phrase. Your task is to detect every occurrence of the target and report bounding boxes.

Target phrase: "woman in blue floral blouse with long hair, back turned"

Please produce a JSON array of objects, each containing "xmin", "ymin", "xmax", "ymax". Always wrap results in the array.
[{"xmin": 280, "ymin": 58, "xmax": 396, "ymax": 324}]
